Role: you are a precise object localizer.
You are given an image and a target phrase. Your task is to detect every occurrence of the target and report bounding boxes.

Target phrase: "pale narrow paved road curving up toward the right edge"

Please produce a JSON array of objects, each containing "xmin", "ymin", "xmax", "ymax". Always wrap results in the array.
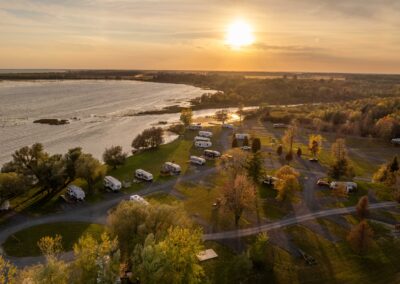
[{"xmin": 203, "ymin": 202, "xmax": 398, "ymax": 241}]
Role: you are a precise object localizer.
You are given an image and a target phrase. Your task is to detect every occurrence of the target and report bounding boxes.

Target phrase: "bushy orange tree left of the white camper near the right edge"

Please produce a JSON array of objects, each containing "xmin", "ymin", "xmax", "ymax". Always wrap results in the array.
[{"xmin": 275, "ymin": 166, "xmax": 300, "ymax": 201}]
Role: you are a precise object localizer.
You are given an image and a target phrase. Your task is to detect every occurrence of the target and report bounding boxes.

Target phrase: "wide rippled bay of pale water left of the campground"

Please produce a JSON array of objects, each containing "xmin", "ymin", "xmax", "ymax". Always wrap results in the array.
[{"xmin": 0, "ymin": 80, "xmax": 216, "ymax": 164}]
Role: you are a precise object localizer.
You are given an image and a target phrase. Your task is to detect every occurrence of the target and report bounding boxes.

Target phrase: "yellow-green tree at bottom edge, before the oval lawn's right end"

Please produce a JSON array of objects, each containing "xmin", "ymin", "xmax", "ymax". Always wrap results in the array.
[{"xmin": 71, "ymin": 233, "xmax": 120, "ymax": 283}]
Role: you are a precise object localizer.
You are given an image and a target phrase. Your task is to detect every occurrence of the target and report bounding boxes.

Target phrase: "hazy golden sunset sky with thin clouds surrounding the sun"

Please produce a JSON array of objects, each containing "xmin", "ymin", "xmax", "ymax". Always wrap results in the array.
[{"xmin": 0, "ymin": 0, "xmax": 400, "ymax": 73}]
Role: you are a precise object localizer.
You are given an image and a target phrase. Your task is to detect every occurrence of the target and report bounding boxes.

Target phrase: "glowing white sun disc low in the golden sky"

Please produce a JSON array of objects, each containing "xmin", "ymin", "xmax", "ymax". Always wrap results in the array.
[{"xmin": 225, "ymin": 20, "xmax": 254, "ymax": 49}]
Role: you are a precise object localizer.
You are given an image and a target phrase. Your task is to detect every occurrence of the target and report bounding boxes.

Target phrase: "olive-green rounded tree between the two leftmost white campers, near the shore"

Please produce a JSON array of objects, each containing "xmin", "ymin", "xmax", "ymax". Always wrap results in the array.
[{"xmin": 76, "ymin": 154, "xmax": 107, "ymax": 194}]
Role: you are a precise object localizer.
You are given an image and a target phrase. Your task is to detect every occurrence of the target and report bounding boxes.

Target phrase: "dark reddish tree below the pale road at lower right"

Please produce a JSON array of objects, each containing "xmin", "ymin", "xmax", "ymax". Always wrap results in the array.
[{"xmin": 347, "ymin": 220, "xmax": 374, "ymax": 254}]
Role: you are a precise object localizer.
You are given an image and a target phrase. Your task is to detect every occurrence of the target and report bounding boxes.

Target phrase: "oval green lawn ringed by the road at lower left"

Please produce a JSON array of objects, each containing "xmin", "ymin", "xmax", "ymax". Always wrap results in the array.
[{"xmin": 3, "ymin": 222, "xmax": 105, "ymax": 257}]
